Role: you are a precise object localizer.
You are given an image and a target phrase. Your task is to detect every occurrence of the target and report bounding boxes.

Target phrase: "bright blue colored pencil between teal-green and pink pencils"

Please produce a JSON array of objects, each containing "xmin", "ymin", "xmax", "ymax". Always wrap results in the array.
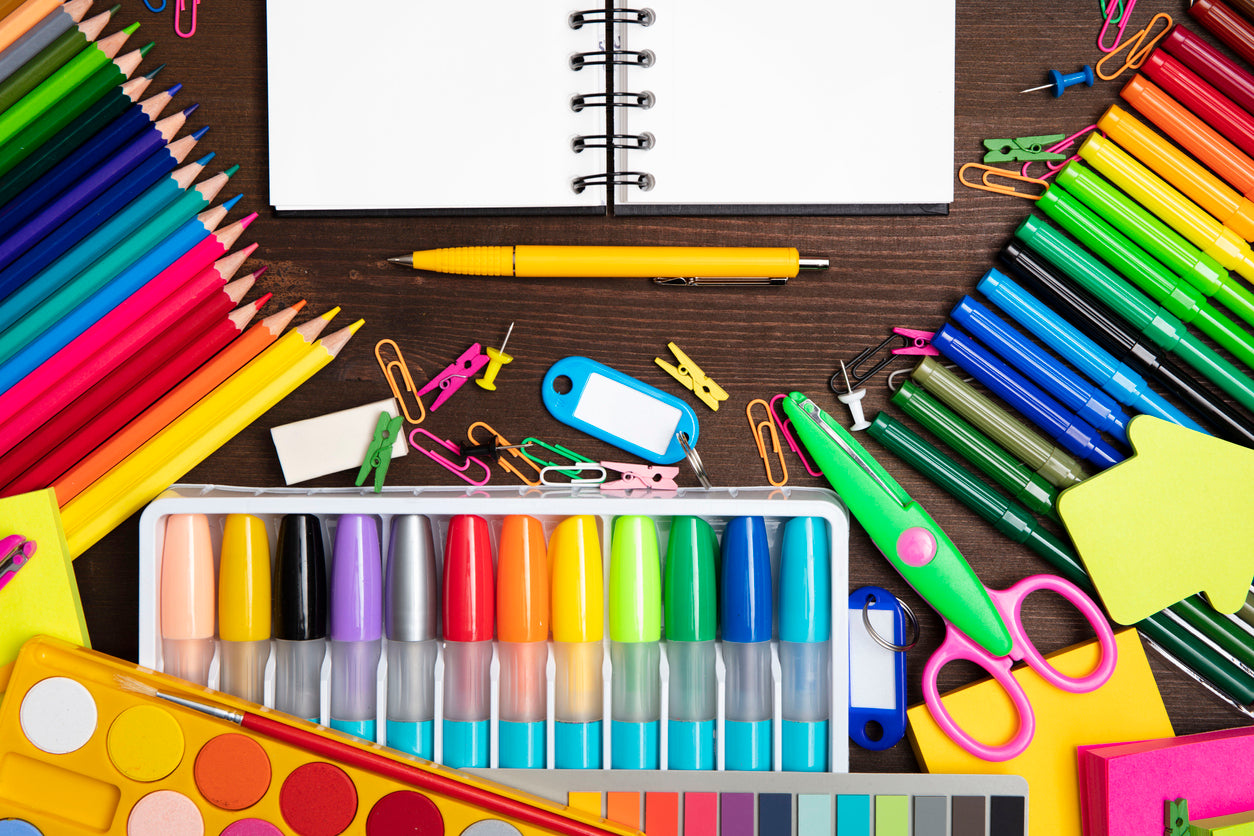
[{"xmin": 0, "ymin": 204, "xmax": 234, "ymax": 390}]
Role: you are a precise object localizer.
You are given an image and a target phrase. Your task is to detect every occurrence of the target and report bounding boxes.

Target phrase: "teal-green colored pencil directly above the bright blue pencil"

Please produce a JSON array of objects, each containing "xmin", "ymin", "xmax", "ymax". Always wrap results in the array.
[{"xmin": 0, "ymin": 182, "xmax": 237, "ymax": 368}]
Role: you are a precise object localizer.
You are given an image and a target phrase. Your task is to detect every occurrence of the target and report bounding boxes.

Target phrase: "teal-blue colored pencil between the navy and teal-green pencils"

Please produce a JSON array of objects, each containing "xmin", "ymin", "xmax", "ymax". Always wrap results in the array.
[{"xmin": 0, "ymin": 154, "xmax": 220, "ymax": 328}]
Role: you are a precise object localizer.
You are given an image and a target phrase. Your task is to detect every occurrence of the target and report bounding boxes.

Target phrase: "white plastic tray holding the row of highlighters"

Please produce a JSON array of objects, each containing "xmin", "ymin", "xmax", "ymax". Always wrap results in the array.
[{"xmin": 139, "ymin": 485, "xmax": 849, "ymax": 772}]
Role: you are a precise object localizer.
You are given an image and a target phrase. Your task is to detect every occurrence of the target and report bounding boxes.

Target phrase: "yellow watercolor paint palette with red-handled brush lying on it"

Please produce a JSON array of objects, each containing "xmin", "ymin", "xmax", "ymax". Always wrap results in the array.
[{"xmin": 0, "ymin": 637, "xmax": 637, "ymax": 836}]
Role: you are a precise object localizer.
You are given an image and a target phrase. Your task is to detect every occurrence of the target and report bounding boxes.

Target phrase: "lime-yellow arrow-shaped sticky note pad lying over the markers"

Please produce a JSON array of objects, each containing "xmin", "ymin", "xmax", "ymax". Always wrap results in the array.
[{"xmin": 1058, "ymin": 415, "xmax": 1254, "ymax": 624}]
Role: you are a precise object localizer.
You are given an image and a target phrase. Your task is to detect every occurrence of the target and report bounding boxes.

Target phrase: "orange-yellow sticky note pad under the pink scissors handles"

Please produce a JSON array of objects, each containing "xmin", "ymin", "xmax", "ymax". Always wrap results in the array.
[{"xmin": 907, "ymin": 628, "xmax": 1175, "ymax": 836}]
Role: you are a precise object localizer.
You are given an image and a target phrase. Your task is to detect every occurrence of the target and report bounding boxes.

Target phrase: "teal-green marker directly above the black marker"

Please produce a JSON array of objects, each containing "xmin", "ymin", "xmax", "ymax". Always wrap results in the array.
[{"xmin": 1014, "ymin": 217, "xmax": 1254, "ymax": 410}]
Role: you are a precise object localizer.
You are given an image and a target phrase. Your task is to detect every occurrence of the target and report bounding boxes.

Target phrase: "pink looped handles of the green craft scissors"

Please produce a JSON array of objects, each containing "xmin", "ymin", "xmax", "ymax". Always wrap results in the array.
[{"xmin": 923, "ymin": 575, "xmax": 1117, "ymax": 761}]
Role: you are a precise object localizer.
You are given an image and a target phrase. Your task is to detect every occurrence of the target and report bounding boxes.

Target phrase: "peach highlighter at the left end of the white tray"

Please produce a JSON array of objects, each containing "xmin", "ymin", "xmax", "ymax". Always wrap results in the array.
[{"xmin": 161, "ymin": 514, "xmax": 214, "ymax": 686}]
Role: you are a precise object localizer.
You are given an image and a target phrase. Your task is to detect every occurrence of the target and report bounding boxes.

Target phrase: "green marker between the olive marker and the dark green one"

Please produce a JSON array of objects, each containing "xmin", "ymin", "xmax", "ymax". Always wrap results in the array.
[{"xmin": 893, "ymin": 380, "xmax": 1058, "ymax": 519}]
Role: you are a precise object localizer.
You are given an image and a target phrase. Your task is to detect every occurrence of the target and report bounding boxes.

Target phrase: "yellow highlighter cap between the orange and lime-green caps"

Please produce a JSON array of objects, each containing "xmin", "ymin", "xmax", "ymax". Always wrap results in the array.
[{"xmin": 549, "ymin": 515, "xmax": 604, "ymax": 642}]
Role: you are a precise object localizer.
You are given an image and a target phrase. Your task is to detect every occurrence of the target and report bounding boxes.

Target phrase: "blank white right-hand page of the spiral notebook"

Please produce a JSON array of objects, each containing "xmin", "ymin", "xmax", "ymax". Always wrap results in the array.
[{"xmin": 616, "ymin": 0, "xmax": 954, "ymax": 206}]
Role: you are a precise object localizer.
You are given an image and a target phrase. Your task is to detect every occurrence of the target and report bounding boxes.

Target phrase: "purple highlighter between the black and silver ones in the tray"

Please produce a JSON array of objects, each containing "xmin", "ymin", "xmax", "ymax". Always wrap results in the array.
[{"xmin": 330, "ymin": 514, "xmax": 384, "ymax": 741}]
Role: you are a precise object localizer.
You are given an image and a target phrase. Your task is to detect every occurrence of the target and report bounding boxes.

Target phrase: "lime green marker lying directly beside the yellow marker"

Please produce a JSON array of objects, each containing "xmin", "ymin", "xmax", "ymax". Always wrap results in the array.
[{"xmin": 1053, "ymin": 160, "xmax": 1254, "ymax": 325}]
